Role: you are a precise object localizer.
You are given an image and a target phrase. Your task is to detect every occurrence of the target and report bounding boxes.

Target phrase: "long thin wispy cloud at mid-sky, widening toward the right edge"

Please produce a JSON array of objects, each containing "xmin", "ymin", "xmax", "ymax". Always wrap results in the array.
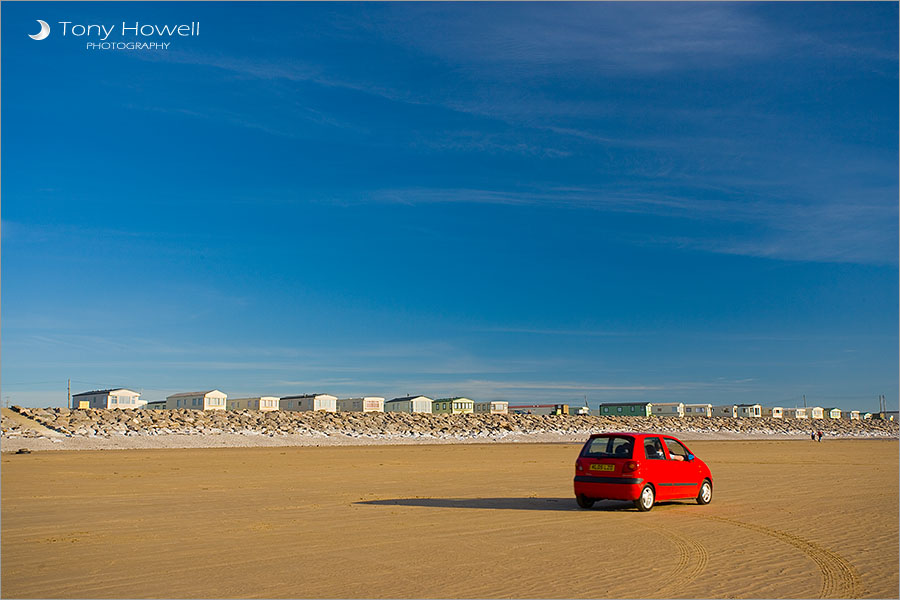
[{"xmin": 365, "ymin": 187, "xmax": 898, "ymax": 264}]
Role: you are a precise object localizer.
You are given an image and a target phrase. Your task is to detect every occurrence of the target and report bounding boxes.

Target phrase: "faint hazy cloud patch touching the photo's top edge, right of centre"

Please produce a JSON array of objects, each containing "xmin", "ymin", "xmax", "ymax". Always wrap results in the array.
[{"xmin": 376, "ymin": 3, "xmax": 778, "ymax": 77}]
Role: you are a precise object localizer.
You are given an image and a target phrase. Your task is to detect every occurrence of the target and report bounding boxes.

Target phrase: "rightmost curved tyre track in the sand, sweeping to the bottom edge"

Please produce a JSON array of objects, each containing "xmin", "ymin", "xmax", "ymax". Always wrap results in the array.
[{"xmin": 704, "ymin": 516, "xmax": 863, "ymax": 598}]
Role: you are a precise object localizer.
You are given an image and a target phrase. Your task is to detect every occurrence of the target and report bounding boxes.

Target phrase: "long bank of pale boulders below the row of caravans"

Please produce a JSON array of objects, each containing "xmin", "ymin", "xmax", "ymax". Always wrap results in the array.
[{"xmin": 2, "ymin": 407, "xmax": 900, "ymax": 439}]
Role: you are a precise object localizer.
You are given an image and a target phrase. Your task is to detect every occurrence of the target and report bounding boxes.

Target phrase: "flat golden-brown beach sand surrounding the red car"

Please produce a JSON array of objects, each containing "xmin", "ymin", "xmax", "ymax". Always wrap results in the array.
[{"xmin": 0, "ymin": 440, "xmax": 900, "ymax": 598}]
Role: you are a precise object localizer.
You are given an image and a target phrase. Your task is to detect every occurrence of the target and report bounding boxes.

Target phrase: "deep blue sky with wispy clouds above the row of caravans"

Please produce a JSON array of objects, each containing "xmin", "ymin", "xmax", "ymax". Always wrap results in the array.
[{"xmin": 0, "ymin": 2, "xmax": 898, "ymax": 410}]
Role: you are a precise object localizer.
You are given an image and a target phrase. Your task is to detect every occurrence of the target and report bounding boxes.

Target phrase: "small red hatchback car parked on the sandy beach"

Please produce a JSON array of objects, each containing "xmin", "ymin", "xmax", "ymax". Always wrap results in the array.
[{"xmin": 575, "ymin": 433, "xmax": 712, "ymax": 511}]
